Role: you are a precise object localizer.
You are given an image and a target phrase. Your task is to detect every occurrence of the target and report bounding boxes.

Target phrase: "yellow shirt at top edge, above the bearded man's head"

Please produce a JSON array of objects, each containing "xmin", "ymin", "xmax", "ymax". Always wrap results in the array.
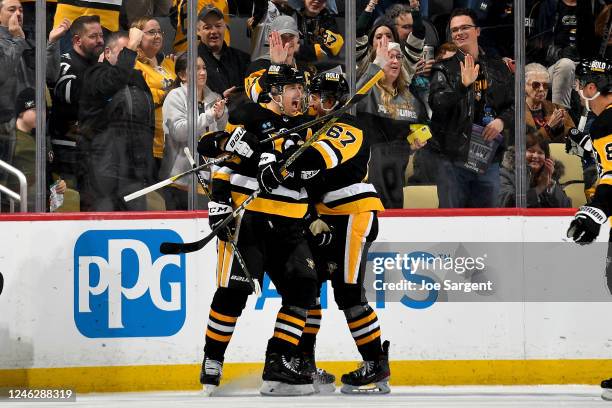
[{"xmin": 53, "ymin": 0, "xmax": 120, "ymax": 31}]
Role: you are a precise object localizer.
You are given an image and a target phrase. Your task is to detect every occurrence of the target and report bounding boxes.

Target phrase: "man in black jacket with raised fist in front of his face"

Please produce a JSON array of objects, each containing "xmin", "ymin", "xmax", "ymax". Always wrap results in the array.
[{"xmin": 77, "ymin": 28, "xmax": 155, "ymax": 211}]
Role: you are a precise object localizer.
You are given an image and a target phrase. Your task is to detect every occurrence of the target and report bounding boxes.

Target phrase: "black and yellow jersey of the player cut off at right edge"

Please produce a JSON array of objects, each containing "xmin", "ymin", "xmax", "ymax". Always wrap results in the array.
[{"xmin": 590, "ymin": 104, "xmax": 612, "ymax": 217}]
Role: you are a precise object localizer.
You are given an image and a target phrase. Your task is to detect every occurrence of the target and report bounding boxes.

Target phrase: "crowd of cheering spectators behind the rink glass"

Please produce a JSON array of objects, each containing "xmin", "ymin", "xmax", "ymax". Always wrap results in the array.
[{"xmin": 0, "ymin": 0, "xmax": 612, "ymax": 211}]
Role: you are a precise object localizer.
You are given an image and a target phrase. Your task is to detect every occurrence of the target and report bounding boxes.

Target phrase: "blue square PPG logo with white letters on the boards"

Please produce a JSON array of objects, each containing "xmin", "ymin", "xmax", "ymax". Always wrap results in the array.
[{"xmin": 74, "ymin": 230, "xmax": 186, "ymax": 338}]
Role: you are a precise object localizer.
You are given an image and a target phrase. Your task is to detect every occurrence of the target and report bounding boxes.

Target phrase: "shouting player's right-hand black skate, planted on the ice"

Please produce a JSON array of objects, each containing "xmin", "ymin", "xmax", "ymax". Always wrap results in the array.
[{"xmin": 259, "ymin": 353, "xmax": 315, "ymax": 396}]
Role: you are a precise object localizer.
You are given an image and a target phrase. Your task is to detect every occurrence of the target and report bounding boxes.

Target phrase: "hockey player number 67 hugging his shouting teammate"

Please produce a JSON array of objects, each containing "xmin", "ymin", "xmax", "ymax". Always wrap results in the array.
[{"xmin": 272, "ymin": 71, "xmax": 390, "ymax": 393}]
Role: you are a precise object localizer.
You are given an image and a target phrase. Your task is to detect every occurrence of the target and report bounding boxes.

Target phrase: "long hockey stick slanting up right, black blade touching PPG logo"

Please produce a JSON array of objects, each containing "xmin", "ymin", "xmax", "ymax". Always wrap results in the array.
[{"xmin": 159, "ymin": 69, "xmax": 384, "ymax": 254}]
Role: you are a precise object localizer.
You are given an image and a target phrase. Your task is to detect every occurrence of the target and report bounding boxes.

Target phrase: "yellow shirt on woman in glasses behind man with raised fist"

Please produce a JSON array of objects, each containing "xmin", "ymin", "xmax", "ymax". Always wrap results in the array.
[{"xmin": 134, "ymin": 58, "xmax": 176, "ymax": 159}]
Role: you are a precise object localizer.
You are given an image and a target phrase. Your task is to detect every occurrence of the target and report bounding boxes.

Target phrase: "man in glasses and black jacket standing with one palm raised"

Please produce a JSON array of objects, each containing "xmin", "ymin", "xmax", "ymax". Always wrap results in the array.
[{"xmin": 429, "ymin": 9, "xmax": 514, "ymax": 208}]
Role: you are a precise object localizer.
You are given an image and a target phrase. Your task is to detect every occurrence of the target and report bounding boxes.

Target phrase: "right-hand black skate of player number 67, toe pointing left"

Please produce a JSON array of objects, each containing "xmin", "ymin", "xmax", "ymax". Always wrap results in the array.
[{"xmin": 340, "ymin": 341, "xmax": 391, "ymax": 394}]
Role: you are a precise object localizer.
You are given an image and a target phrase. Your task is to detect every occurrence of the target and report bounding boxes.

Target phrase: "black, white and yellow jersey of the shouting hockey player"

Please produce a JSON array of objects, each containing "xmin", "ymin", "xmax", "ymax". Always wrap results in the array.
[{"xmin": 212, "ymin": 103, "xmax": 311, "ymax": 218}]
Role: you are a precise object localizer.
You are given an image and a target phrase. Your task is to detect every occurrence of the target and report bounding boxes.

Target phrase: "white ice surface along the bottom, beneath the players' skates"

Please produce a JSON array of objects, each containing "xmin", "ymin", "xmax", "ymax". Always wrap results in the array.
[{"xmin": 5, "ymin": 385, "xmax": 612, "ymax": 408}]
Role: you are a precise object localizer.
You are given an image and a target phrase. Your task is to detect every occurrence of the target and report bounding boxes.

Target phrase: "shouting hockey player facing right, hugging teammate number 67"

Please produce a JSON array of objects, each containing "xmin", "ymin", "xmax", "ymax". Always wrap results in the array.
[{"xmin": 198, "ymin": 65, "xmax": 317, "ymax": 395}]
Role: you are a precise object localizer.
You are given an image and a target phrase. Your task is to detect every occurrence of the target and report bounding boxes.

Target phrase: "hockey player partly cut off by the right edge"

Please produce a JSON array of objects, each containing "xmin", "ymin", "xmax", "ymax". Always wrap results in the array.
[{"xmin": 567, "ymin": 59, "xmax": 612, "ymax": 400}]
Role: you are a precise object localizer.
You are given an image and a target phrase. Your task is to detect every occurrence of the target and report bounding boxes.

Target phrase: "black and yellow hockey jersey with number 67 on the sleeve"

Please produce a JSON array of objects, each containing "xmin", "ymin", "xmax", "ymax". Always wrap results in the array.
[{"xmin": 289, "ymin": 115, "xmax": 384, "ymax": 215}]
